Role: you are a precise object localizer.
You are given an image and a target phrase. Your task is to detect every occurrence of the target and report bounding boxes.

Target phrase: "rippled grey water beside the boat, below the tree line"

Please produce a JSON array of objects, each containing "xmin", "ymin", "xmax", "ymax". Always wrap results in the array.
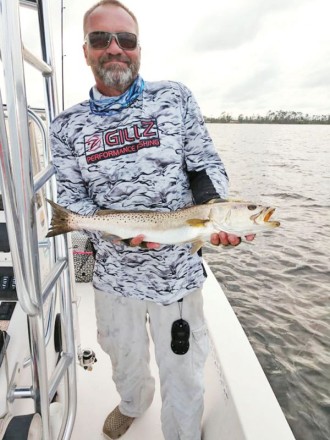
[{"xmin": 204, "ymin": 124, "xmax": 330, "ymax": 440}]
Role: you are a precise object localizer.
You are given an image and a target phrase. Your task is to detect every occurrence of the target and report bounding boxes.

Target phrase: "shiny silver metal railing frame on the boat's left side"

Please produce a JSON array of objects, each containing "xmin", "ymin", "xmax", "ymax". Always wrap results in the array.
[{"xmin": 0, "ymin": 0, "xmax": 76, "ymax": 440}]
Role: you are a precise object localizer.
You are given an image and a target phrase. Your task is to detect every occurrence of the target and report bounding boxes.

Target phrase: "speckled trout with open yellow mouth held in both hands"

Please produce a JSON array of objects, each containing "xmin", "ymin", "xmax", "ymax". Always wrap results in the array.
[{"xmin": 47, "ymin": 200, "xmax": 280, "ymax": 253}]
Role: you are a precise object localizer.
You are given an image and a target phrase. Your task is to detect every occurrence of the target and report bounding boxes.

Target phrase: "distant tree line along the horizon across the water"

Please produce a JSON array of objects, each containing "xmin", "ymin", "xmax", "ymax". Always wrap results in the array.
[{"xmin": 204, "ymin": 110, "xmax": 330, "ymax": 124}]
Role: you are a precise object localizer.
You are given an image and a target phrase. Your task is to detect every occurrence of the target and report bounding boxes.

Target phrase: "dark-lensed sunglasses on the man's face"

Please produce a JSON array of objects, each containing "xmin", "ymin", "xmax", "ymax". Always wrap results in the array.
[{"xmin": 85, "ymin": 31, "xmax": 138, "ymax": 50}]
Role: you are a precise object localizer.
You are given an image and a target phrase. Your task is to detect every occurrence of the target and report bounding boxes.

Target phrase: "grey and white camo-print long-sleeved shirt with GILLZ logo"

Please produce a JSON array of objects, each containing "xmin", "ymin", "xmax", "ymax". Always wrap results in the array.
[{"xmin": 51, "ymin": 81, "xmax": 228, "ymax": 304}]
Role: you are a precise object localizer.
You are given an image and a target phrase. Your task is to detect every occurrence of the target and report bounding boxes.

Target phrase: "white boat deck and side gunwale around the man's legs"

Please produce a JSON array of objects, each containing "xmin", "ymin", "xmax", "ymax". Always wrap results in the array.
[{"xmin": 72, "ymin": 265, "xmax": 294, "ymax": 440}]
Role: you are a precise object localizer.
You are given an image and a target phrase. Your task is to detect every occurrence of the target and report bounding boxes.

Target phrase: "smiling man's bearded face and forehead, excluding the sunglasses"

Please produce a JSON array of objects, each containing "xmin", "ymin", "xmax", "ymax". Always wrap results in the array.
[{"xmin": 83, "ymin": 6, "xmax": 141, "ymax": 94}]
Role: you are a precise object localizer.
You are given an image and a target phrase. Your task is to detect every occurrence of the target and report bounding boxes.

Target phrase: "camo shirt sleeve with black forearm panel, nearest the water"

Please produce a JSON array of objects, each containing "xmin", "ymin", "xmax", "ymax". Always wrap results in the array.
[{"xmin": 180, "ymin": 84, "xmax": 228, "ymax": 204}]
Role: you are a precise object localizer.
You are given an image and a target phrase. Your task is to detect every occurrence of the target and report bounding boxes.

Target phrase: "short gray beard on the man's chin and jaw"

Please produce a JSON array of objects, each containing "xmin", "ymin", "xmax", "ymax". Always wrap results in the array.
[{"xmin": 97, "ymin": 64, "xmax": 139, "ymax": 92}]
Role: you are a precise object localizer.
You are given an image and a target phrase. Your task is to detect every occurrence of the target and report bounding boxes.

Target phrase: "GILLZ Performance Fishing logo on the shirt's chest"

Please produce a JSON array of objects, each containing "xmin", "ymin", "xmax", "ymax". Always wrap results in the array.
[{"xmin": 84, "ymin": 119, "xmax": 160, "ymax": 164}]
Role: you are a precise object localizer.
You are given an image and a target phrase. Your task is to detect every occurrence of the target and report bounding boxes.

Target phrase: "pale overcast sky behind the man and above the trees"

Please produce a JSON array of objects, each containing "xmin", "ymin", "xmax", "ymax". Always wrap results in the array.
[{"xmin": 7, "ymin": 0, "xmax": 330, "ymax": 117}]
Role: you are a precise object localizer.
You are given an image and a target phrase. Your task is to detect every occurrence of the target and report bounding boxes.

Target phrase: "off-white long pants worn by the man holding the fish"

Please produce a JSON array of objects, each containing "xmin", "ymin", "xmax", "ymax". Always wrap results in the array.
[{"xmin": 95, "ymin": 289, "xmax": 209, "ymax": 440}]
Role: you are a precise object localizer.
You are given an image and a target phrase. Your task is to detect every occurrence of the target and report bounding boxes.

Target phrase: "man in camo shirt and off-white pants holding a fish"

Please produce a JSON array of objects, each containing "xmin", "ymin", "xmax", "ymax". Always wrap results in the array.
[{"xmin": 51, "ymin": 0, "xmax": 253, "ymax": 440}]
